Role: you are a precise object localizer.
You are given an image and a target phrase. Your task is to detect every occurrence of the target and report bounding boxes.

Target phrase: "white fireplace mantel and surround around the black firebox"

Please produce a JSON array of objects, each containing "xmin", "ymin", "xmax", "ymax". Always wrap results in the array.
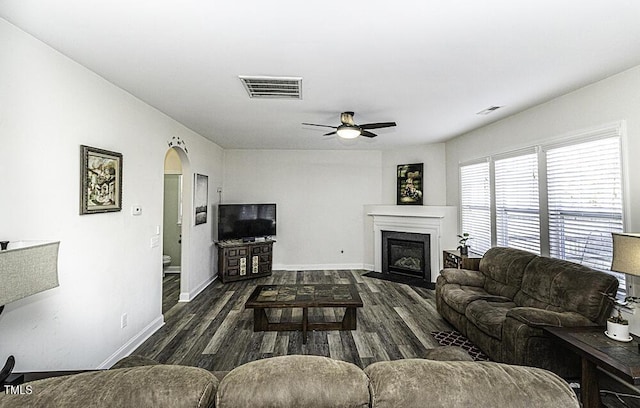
[{"xmin": 367, "ymin": 205, "xmax": 458, "ymax": 282}]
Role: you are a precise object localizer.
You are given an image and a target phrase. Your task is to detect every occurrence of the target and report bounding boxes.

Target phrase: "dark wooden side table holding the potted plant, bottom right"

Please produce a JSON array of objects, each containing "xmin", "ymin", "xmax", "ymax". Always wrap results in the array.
[{"xmin": 544, "ymin": 326, "xmax": 640, "ymax": 408}]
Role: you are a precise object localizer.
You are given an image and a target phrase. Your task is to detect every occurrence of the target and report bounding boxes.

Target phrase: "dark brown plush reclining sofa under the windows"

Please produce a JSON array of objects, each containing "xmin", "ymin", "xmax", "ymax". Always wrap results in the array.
[{"xmin": 436, "ymin": 247, "xmax": 618, "ymax": 378}]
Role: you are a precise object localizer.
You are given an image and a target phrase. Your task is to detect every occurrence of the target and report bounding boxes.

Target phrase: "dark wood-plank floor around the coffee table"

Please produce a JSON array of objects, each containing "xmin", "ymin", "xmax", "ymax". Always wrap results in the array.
[{"xmin": 134, "ymin": 270, "xmax": 451, "ymax": 371}]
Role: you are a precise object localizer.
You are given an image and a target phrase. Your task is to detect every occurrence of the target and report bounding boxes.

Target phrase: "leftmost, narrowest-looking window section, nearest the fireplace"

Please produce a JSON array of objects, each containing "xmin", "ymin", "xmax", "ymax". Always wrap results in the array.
[{"xmin": 460, "ymin": 162, "xmax": 491, "ymax": 254}]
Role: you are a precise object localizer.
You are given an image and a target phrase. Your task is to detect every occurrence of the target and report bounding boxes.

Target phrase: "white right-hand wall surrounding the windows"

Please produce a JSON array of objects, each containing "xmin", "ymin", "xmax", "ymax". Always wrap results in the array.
[{"xmin": 446, "ymin": 66, "xmax": 640, "ymax": 334}]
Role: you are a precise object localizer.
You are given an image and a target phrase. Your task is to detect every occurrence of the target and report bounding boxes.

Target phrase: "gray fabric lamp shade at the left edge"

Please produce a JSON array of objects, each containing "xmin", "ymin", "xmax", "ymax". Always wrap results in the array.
[{"xmin": 0, "ymin": 241, "xmax": 60, "ymax": 306}]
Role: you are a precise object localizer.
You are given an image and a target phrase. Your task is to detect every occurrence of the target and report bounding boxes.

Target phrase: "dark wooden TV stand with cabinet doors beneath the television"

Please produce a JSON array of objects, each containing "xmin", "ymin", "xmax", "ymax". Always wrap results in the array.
[{"xmin": 216, "ymin": 240, "xmax": 275, "ymax": 283}]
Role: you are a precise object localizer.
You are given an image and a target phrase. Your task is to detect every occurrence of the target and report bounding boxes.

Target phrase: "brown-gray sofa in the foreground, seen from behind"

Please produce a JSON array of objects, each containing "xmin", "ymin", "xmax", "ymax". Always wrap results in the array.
[{"xmin": 0, "ymin": 353, "xmax": 580, "ymax": 408}]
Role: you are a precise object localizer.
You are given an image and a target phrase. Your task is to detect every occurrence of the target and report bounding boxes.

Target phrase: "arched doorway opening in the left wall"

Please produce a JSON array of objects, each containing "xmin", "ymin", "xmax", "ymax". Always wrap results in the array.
[{"xmin": 162, "ymin": 147, "xmax": 192, "ymax": 314}]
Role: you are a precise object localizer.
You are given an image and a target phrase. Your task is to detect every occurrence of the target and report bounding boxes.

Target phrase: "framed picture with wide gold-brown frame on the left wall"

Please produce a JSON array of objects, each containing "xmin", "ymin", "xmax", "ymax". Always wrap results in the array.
[{"xmin": 80, "ymin": 145, "xmax": 122, "ymax": 215}]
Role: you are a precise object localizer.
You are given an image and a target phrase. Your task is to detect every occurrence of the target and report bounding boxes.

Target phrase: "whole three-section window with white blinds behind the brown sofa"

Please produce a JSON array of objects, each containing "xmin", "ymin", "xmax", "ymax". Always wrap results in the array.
[{"xmin": 460, "ymin": 123, "xmax": 626, "ymax": 295}]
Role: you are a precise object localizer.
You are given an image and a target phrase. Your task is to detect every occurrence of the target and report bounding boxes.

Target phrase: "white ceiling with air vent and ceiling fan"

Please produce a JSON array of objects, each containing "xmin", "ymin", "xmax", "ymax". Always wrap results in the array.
[{"xmin": 0, "ymin": 0, "xmax": 640, "ymax": 149}]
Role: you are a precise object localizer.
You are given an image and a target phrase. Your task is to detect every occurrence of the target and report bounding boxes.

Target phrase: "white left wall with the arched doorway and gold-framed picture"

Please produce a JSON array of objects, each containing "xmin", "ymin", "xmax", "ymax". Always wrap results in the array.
[{"xmin": 0, "ymin": 19, "xmax": 223, "ymax": 371}]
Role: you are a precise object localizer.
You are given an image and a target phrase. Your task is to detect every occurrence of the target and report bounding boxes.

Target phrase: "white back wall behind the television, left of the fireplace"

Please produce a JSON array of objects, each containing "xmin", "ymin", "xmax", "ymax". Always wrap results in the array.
[{"xmin": 223, "ymin": 150, "xmax": 382, "ymax": 269}]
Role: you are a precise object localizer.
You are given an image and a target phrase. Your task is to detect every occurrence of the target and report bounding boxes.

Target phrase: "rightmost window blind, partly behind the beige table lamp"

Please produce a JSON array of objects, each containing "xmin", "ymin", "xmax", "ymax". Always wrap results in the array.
[{"xmin": 546, "ymin": 136, "xmax": 625, "ymax": 294}]
